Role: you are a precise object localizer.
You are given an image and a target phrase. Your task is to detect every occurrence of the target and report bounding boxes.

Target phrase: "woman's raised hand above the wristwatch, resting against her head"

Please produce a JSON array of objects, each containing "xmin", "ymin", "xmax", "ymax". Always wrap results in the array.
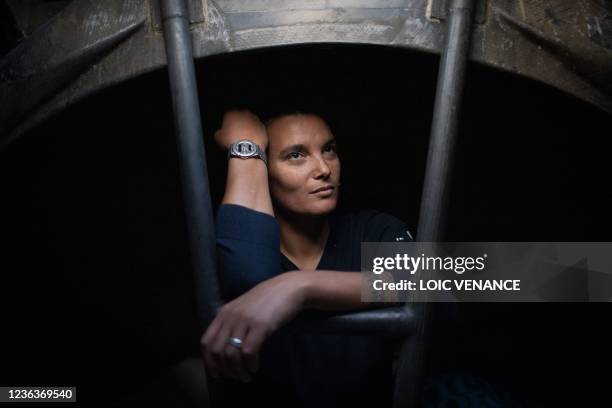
[{"xmin": 215, "ymin": 110, "xmax": 268, "ymax": 150}]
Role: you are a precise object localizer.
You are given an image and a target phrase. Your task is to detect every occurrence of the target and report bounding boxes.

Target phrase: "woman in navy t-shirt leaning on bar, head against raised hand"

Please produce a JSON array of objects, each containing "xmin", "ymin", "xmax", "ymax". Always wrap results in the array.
[{"xmin": 201, "ymin": 111, "xmax": 412, "ymax": 407}]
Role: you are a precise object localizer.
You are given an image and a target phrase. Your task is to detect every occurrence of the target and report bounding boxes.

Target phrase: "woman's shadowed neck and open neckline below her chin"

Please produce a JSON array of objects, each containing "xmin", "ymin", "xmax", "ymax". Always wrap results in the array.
[{"xmin": 275, "ymin": 207, "xmax": 329, "ymax": 263}]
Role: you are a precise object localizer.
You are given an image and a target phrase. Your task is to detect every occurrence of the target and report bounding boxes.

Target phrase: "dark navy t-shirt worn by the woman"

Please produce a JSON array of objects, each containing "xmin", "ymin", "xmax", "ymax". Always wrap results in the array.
[{"xmin": 211, "ymin": 204, "xmax": 412, "ymax": 408}]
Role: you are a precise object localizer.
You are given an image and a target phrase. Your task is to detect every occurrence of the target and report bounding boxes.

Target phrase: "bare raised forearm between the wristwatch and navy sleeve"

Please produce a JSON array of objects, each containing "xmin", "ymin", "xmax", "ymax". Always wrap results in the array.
[{"xmin": 221, "ymin": 158, "xmax": 274, "ymax": 216}]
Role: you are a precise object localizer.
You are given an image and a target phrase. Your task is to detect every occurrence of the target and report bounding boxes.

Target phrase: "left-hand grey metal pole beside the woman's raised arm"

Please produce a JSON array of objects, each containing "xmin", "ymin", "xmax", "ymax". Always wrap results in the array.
[{"xmin": 161, "ymin": 0, "xmax": 221, "ymax": 328}]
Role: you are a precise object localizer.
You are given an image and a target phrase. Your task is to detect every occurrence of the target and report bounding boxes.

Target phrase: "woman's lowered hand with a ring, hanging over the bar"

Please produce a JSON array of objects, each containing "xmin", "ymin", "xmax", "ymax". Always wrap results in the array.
[{"xmin": 200, "ymin": 272, "xmax": 306, "ymax": 382}]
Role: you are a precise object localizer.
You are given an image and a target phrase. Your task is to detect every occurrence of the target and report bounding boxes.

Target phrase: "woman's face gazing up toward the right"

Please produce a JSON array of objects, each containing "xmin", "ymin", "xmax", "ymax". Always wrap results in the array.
[{"xmin": 267, "ymin": 114, "xmax": 340, "ymax": 215}]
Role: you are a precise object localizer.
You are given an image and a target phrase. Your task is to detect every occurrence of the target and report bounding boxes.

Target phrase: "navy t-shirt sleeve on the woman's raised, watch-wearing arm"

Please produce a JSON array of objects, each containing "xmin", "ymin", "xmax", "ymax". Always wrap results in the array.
[{"xmin": 216, "ymin": 204, "xmax": 280, "ymax": 300}]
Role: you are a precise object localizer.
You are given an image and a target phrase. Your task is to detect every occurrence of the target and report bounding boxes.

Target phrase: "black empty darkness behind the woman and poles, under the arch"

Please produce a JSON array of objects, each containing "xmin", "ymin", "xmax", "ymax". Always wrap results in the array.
[{"xmin": 0, "ymin": 44, "xmax": 612, "ymax": 407}]
